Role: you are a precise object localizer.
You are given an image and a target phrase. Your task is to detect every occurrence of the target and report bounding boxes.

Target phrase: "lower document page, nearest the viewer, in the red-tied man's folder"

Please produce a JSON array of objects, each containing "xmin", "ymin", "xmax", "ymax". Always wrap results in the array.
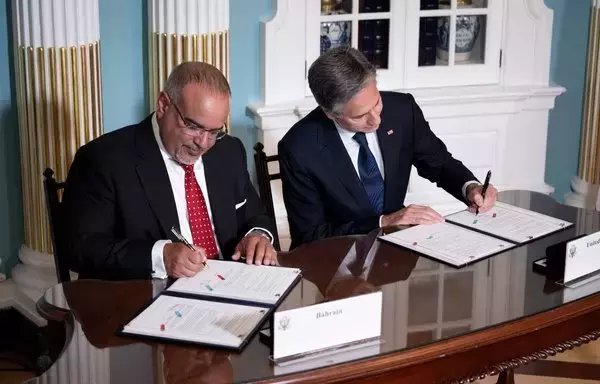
[{"xmin": 123, "ymin": 295, "xmax": 268, "ymax": 348}]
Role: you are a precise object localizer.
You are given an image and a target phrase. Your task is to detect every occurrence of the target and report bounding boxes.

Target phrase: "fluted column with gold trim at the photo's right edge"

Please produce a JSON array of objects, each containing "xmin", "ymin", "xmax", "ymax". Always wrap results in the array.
[{"xmin": 565, "ymin": 0, "xmax": 600, "ymax": 208}]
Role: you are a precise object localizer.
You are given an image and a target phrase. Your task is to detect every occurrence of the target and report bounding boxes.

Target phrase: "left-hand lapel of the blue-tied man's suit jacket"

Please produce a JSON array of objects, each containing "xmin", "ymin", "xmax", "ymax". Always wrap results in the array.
[{"xmin": 322, "ymin": 117, "xmax": 373, "ymax": 209}]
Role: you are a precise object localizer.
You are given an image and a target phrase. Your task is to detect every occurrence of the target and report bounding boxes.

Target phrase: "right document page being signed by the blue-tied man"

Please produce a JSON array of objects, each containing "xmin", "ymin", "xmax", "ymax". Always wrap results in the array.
[{"xmin": 446, "ymin": 202, "xmax": 571, "ymax": 244}]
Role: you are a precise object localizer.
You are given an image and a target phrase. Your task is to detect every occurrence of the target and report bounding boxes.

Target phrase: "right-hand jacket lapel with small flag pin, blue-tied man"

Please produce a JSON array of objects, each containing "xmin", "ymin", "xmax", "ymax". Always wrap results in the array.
[{"xmin": 377, "ymin": 108, "xmax": 401, "ymax": 211}]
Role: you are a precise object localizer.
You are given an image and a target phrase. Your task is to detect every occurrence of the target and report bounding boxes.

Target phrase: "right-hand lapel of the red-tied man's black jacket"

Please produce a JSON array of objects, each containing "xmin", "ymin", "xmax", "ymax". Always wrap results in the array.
[{"xmin": 202, "ymin": 143, "xmax": 237, "ymax": 249}]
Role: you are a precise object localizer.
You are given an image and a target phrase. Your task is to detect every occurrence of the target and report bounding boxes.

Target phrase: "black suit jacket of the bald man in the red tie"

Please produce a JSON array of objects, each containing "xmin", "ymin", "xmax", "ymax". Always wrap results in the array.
[{"xmin": 63, "ymin": 113, "xmax": 273, "ymax": 279}]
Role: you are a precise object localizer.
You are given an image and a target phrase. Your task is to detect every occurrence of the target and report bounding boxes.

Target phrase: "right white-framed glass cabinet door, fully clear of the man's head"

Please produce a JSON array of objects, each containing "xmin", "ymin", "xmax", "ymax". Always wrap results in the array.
[{"xmin": 406, "ymin": 0, "xmax": 503, "ymax": 88}]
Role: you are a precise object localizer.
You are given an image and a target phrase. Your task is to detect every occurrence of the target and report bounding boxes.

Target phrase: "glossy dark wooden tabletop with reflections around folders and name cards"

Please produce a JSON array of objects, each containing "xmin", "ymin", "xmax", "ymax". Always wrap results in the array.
[{"xmin": 30, "ymin": 192, "xmax": 600, "ymax": 383}]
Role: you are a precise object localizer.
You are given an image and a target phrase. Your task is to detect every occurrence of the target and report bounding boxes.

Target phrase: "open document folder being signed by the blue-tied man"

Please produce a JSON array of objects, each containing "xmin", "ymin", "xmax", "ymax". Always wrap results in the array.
[{"xmin": 380, "ymin": 202, "xmax": 573, "ymax": 267}]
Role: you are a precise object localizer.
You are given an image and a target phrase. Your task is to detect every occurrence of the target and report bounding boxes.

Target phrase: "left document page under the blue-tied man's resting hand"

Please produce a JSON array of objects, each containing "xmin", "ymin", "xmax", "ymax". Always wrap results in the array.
[{"xmin": 380, "ymin": 222, "xmax": 515, "ymax": 266}]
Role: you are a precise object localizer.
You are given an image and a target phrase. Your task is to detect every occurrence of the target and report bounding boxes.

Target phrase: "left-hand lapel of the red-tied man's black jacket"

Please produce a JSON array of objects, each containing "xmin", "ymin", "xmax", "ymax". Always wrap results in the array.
[{"xmin": 135, "ymin": 117, "xmax": 179, "ymax": 238}]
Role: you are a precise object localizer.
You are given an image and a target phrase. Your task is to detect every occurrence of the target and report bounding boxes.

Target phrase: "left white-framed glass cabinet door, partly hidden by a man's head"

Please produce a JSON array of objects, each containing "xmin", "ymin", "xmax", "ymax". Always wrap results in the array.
[{"xmin": 306, "ymin": 0, "xmax": 405, "ymax": 95}]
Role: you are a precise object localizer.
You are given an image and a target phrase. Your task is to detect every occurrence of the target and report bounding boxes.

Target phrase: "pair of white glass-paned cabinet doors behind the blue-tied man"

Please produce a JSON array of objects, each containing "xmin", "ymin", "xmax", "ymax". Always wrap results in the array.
[{"xmin": 306, "ymin": 0, "xmax": 505, "ymax": 91}]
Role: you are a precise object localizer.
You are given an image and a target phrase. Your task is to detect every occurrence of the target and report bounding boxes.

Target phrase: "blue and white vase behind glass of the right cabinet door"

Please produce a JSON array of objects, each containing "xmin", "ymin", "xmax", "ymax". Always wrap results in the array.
[{"xmin": 437, "ymin": 3, "xmax": 481, "ymax": 63}]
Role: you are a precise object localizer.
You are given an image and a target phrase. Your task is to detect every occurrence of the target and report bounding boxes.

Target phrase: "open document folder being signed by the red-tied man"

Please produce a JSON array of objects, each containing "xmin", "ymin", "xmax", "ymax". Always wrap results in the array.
[{"xmin": 119, "ymin": 260, "xmax": 301, "ymax": 351}]
